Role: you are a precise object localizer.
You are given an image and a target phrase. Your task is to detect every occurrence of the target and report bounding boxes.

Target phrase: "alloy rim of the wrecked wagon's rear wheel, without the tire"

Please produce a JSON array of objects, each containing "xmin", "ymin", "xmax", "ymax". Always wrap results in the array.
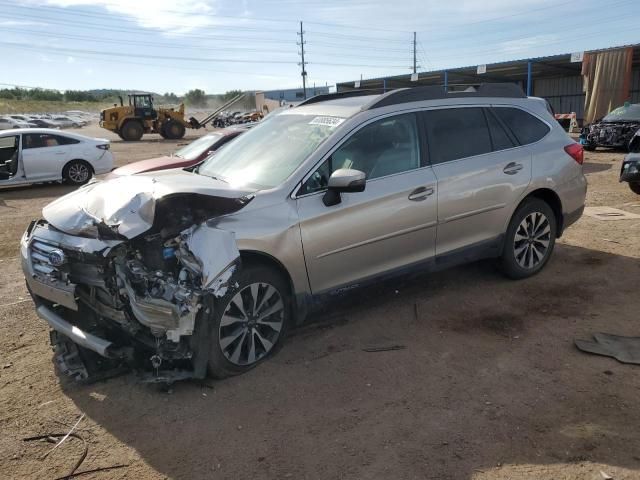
[{"xmin": 513, "ymin": 212, "xmax": 551, "ymax": 270}]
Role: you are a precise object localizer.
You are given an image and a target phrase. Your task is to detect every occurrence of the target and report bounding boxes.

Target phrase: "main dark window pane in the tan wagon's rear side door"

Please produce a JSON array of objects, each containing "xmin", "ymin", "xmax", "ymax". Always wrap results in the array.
[{"xmin": 425, "ymin": 107, "xmax": 491, "ymax": 164}]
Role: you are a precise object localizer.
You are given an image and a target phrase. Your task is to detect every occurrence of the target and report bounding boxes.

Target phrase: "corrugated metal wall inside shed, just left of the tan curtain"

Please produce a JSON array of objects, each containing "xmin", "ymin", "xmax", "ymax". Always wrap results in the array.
[{"xmin": 533, "ymin": 75, "xmax": 585, "ymax": 122}]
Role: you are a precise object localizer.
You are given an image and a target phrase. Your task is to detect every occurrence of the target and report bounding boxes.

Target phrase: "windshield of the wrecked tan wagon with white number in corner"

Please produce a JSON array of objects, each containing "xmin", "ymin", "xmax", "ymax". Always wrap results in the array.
[{"xmin": 198, "ymin": 115, "xmax": 344, "ymax": 188}]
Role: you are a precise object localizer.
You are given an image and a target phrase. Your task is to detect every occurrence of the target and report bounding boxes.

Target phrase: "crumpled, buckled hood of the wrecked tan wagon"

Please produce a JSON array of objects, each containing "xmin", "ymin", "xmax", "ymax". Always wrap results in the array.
[{"xmin": 42, "ymin": 170, "xmax": 253, "ymax": 239}]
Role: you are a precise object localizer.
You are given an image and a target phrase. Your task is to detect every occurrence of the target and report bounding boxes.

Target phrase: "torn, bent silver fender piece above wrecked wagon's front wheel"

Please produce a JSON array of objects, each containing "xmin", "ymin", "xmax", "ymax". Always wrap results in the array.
[{"xmin": 182, "ymin": 223, "xmax": 240, "ymax": 296}]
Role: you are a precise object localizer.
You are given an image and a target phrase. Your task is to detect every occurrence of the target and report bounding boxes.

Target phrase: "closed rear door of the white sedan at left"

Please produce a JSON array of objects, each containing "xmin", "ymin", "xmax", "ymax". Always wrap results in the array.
[{"xmin": 22, "ymin": 133, "xmax": 71, "ymax": 181}]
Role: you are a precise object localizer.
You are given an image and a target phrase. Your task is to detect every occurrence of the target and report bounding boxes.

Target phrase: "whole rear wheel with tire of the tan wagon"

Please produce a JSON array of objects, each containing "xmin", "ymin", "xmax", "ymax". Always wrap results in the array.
[{"xmin": 500, "ymin": 198, "xmax": 558, "ymax": 279}]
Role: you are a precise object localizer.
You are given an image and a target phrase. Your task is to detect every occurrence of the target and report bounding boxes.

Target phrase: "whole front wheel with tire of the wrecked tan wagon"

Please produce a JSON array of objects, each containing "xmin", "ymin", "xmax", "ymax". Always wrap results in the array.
[{"xmin": 209, "ymin": 264, "xmax": 291, "ymax": 378}]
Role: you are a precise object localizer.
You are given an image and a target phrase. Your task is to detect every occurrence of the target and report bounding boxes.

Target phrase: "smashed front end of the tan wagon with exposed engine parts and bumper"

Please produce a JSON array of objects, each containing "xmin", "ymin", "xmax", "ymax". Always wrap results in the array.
[{"xmin": 21, "ymin": 174, "xmax": 251, "ymax": 383}]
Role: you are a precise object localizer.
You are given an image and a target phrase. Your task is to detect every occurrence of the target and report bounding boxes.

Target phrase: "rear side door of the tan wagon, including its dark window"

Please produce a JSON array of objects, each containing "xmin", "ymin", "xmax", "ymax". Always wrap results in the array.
[{"xmin": 425, "ymin": 106, "xmax": 531, "ymax": 256}]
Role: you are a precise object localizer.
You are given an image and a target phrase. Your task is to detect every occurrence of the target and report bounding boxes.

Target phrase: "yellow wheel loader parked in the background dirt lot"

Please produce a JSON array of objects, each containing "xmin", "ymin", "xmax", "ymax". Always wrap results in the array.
[{"xmin": 100, "ymin": 93, "xmax": 244, "ymax": 141}]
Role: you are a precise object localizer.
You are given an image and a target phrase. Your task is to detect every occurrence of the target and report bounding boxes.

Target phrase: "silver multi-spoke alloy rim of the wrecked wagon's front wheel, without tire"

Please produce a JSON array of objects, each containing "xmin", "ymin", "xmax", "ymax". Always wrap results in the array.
[{"xmin": 218, "ymin": 282, "xmax": 285, "ymax": 366}]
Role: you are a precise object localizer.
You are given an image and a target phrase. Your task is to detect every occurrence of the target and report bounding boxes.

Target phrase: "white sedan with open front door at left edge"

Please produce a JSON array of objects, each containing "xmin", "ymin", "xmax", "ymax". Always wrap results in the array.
[{"xmin": 0, "ymin": 128, "xmax": 113, "ymax": 186}]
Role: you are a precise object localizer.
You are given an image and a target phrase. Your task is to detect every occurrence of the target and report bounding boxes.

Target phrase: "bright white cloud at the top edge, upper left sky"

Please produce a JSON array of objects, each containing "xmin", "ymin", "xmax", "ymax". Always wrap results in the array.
[{"xmin": 39, "ymin": 0, "xmax": 219, "ymax": 32}]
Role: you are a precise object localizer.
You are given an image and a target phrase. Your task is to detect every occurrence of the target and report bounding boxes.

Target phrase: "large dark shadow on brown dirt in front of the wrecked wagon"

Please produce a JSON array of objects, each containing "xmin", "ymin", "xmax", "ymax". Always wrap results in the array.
[{"xmin": 61, "ymin": 245, "xmax": 640, "ymax": 480}]
